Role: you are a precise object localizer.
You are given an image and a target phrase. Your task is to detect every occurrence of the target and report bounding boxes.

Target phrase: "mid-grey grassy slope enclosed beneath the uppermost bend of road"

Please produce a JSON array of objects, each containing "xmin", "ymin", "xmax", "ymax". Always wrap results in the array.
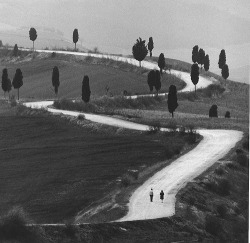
[{"xmin": 0, "ymin": 51, "xmax": 185, "ymax": 99}]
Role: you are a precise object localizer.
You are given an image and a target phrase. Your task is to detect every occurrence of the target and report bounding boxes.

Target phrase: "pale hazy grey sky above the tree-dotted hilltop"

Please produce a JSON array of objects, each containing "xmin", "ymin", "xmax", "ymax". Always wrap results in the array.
[{"xmin": 0, "ymin": 0, "xmax": 250, "ymax": 82}]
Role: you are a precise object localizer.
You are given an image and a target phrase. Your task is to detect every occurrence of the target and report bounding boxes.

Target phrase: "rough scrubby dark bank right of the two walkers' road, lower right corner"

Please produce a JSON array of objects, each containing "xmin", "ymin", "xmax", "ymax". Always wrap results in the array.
[{"xmin": 176, "ymin": 134, "xmax": 249, "ymax": 242}]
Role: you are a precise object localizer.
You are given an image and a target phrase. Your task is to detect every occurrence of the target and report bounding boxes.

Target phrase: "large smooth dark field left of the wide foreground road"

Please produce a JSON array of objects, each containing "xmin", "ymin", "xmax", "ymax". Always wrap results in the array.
[{"xmin": 0, "ymin": 101, "xmax": 195, "ymax": 223}]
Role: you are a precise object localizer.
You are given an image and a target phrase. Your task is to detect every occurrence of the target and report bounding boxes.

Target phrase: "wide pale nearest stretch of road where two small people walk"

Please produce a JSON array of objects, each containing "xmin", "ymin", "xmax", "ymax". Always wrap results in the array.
[{"xmin": 118, "ymin": 130, "xmax": 243, "ymax": 221}]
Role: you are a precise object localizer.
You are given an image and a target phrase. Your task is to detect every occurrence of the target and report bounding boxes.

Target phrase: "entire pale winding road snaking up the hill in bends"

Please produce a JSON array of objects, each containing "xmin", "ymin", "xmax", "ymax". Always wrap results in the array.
[{"xmin": 24, "ymin": 50, "xmax": 243, "ymax": 221}]
